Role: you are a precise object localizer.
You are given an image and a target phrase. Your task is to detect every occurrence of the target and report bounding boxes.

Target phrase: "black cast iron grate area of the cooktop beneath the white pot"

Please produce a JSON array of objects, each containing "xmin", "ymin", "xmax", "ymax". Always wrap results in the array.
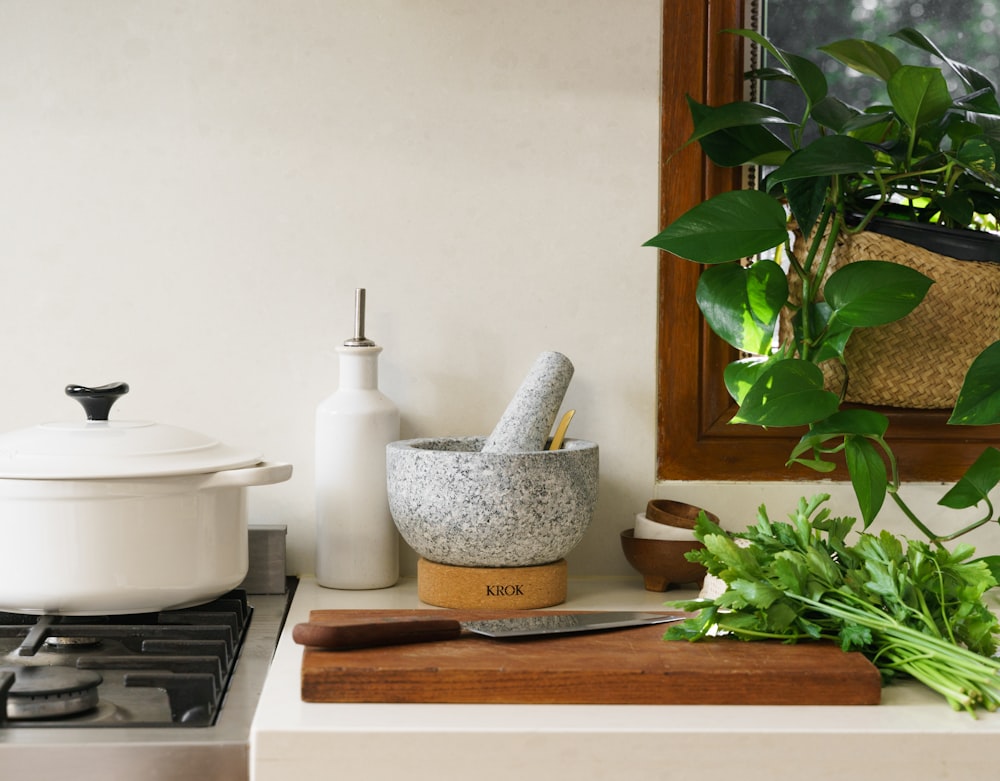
[{"xmin": 0, "ymin": 590, "xmax": 253, "ymax": 728}]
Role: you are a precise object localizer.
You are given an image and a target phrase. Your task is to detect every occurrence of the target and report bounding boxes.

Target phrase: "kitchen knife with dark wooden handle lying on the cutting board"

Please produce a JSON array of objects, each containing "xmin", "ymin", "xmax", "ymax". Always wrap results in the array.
[{"xmin": 292, "ymin": 611, "xmax": 688, "ymax": 651}]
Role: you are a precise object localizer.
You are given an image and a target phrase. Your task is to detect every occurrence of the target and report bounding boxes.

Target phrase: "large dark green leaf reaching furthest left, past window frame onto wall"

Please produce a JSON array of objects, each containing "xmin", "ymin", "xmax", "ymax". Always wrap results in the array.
[{"xmin": 644, "ymin": 190, "xmax": 788, "ymax": 263}]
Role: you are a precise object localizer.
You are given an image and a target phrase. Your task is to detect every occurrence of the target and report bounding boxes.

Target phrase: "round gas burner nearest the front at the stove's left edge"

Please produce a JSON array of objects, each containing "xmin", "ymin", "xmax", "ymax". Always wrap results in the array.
[{"xmin": 4, "ymin": 667, "xmax": 104, "ymax": 720}]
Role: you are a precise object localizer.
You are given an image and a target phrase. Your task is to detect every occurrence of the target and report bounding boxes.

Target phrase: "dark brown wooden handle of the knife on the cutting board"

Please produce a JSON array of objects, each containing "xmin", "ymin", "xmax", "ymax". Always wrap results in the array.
[{"xmin": 292, "ymin": 618, "xmax": 462, "ymax": 651}]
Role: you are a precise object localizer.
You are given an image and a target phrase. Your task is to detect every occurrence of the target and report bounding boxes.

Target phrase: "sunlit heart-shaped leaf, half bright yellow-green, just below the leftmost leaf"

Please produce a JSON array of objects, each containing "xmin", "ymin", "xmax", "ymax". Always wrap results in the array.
[{"xmin": 695, "ymin": 259, "xmax": 788, "ymax": 355}]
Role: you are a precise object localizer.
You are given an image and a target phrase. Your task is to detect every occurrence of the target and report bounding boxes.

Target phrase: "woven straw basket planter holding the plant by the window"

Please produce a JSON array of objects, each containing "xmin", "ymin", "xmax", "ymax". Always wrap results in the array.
[{"xmin": 781, "ymin": 227, "xmax": 1000, "ymax": 409}]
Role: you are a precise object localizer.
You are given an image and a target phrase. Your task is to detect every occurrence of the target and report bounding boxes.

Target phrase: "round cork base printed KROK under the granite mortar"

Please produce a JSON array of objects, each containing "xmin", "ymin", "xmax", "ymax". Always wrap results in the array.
[{"xmin": 417, "ymin": 559, "xmax": 567, "ymax": 610}]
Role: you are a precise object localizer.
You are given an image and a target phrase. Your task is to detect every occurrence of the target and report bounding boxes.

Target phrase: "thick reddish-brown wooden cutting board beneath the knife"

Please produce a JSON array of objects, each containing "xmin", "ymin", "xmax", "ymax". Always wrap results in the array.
[{"xmin": 302, "ymin": 610, "xmax": 882, "ymax": 705}]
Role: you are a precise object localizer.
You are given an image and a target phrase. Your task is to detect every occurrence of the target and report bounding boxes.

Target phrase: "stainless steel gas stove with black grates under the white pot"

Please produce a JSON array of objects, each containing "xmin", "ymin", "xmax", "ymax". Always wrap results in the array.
[{"xmin": 0, "ymin": 532, "xmax": 297, "ymax": 781}]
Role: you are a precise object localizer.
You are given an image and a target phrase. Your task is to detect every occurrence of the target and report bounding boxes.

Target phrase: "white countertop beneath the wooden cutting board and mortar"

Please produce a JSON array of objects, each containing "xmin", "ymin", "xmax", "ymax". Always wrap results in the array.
[{"xmin": 250, "ymin": 578, "xmax": 1000, "ymax": 781}]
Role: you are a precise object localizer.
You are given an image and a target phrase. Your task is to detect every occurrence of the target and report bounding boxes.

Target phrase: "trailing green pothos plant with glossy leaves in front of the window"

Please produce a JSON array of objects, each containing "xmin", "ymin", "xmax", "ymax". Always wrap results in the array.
[{"xmin": 647, "ymin": 29, "xmax": 1000, "ymax": 572}]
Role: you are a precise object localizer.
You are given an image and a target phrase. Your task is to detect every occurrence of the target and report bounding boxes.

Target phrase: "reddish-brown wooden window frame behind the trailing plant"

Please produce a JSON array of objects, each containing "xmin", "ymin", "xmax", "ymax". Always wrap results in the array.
[{"xmin": 656, "ymin": 0, "xmax": 1000, "ymax": 482}]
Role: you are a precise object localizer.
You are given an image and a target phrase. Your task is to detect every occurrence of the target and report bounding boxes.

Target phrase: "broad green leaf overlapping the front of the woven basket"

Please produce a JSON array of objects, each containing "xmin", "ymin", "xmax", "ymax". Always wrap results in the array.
[{"xmin": 824, "ymin": 260, "xmax": 933, "ymax": 328}]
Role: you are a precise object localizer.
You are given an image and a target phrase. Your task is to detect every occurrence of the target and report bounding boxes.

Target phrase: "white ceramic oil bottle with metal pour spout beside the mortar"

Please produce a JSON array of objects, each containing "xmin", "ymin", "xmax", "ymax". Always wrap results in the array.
[{"xmin": 316, "ymin": 288, "xmax": 399, "ymax": 589}]
